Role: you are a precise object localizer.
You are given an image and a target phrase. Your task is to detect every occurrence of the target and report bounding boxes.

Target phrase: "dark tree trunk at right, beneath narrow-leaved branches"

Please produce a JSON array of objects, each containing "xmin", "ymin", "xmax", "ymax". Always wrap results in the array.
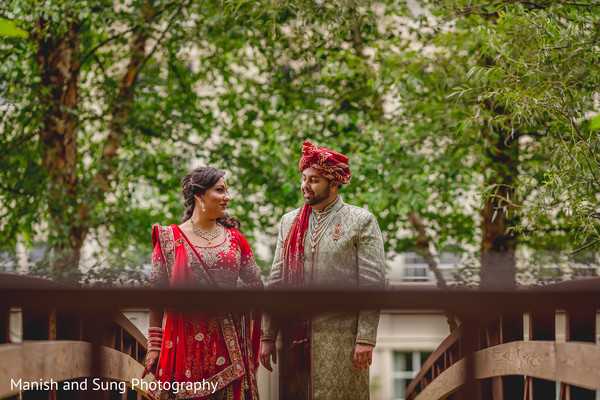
[{"xmin": 480, "ymin": 122, "xmax": 519, "ymax": 289}]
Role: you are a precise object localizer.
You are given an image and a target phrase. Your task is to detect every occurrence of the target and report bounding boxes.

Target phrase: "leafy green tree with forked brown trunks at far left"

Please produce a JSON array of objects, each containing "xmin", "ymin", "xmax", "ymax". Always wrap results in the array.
[{"xmin": 0, "ymin": 0, "xmax": 217, "ymax": 283}]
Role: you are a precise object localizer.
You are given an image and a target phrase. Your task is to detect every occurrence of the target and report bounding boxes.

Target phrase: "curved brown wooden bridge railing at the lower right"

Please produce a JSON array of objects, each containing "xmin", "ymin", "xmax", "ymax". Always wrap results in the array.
[{"xmin": 406, "ymin": 279, "xmax": 600, "ymax": 400}]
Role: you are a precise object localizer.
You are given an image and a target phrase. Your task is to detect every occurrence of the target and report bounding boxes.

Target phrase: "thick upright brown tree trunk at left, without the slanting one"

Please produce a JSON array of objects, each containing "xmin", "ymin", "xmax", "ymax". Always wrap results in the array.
[{"xmin": 36, "ymin": 19, "xmax": 86, "ymax": 283}]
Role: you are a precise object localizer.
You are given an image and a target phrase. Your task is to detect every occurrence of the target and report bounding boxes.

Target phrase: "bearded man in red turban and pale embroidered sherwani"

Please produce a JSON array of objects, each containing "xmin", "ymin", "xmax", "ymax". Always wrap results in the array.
[{"xmin": 260, "ymin": 142, "xmax": 385, "ymax": 400}]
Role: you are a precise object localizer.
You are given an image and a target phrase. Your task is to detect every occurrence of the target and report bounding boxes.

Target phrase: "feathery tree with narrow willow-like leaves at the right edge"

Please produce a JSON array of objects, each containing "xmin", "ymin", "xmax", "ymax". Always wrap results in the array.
[{"xmin": 432, "ymin": 1, "xmax": 600, "ymax": 282}]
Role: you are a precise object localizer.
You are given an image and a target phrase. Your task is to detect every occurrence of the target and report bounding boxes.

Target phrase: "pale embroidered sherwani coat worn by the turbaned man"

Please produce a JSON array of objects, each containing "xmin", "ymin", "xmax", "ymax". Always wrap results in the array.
[{"xmin": 263, "ymin": 197, "xmax": 385, "ymax": 400}]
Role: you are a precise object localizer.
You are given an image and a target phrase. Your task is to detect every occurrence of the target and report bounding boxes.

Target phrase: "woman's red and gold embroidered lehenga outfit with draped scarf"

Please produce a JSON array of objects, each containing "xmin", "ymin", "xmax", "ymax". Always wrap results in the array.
[{"xmin": 148, "ymin": 225, "xmax": 263, "ymax": 400}]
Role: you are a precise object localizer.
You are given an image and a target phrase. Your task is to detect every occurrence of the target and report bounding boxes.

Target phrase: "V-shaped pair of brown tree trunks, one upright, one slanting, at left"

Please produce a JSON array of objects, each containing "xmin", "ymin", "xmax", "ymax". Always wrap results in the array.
[{"xmin": 36, "ymin": 3, "xmax": 156, "ymax": 284}]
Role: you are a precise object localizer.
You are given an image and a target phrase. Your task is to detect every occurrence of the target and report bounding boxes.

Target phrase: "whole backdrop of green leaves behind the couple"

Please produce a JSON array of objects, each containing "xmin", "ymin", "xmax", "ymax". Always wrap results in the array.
[{"xmin": 0, "ymin": 0, "xmax": 600, "ymax": 282}]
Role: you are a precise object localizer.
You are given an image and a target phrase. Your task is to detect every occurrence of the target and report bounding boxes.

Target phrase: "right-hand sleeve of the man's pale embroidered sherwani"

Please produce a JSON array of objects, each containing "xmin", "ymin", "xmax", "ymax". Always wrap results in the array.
[{"xmin": 356, "ymin": 214, "xmax": 385, "ymax": 346}]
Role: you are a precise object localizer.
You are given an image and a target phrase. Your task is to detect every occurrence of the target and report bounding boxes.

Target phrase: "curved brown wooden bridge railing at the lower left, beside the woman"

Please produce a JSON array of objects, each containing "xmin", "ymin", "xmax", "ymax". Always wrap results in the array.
[{"xmin": 0, "ymin": 274, "xmax": 153, "ymax": 399}]
